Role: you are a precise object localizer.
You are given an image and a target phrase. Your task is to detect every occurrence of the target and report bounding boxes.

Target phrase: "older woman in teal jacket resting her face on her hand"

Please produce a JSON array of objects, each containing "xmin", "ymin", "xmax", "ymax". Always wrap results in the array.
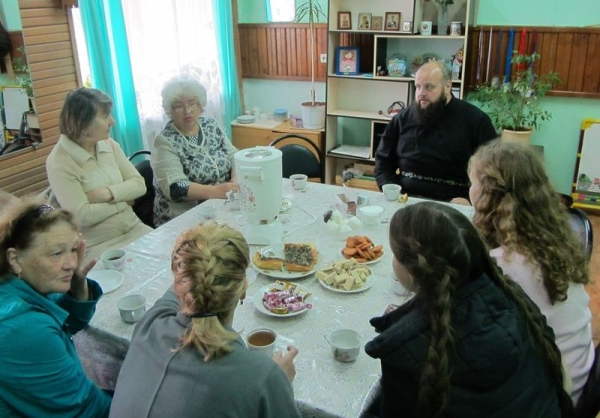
[{"xmin": 0, "ymin": 199, "xmax": 111, "ymax": 417}]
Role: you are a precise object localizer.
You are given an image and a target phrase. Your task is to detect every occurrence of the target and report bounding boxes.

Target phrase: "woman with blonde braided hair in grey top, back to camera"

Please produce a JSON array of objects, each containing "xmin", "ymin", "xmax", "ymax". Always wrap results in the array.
[{"xmin": 110, "ymin": 222, "xmax": 300, "ymax": 418}]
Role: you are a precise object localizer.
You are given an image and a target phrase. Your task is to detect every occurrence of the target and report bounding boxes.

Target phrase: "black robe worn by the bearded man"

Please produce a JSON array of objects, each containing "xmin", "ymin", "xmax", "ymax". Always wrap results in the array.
[{"xmin": 375, "ymin": 97, "xmax": 498, "ymax": 201}]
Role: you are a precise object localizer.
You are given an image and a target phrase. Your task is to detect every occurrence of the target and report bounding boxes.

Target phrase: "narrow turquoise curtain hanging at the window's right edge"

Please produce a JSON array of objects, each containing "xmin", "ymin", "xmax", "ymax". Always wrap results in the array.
[{"xmin": 213, "ymin": 0, "xmax": 242, "ymax": 138}]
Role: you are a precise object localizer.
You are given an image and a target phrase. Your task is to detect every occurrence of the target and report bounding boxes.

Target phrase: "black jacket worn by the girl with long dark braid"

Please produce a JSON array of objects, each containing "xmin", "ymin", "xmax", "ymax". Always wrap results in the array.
[{"xmin": 365, "ymin": 275, "xmax": 560, "ymax": 418}]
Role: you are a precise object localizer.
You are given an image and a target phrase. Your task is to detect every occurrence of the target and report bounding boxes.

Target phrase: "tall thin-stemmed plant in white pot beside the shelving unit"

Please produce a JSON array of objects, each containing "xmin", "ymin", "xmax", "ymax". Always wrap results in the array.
[{"xmin": 296, "ymin": 0, "xmax": 327, "ymax": 129}]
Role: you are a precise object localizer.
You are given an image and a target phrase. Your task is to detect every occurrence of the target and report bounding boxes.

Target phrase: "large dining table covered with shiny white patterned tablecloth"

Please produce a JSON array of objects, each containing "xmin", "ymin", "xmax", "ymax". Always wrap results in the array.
[{"xmin": 74, "ymin": 179, "xmax": 473, "ymax": 417}]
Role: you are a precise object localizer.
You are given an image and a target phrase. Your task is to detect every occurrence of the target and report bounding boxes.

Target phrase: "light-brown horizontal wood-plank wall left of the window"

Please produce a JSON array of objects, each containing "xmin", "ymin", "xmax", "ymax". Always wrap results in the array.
[{"xmin": 0, "ymin": 0, "xmax": 79, "ymax": 195}]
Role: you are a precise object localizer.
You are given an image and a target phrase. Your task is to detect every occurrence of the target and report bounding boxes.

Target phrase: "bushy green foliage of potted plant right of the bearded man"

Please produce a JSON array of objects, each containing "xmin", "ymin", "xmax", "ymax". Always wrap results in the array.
[{"xmin": 472, "ymin": 51, "xmax": 560, "ymax": 142}]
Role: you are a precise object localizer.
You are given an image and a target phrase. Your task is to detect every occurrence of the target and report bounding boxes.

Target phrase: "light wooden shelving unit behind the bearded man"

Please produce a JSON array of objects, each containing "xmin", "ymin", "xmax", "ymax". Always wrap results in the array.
[{"xmin": 325, "ymin": 0, "xmax": 472, "ymax": 183}]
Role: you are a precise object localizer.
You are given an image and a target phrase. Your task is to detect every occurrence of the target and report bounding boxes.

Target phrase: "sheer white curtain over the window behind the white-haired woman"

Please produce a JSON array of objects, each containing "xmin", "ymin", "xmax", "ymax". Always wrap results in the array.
[{"xmin": 122, "ymin": 0, "xmax": 224, "ymax": 149}]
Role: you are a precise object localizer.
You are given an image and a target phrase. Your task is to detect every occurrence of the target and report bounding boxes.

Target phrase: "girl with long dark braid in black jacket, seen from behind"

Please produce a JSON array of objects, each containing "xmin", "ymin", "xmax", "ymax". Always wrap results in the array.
[{"xmin": 365, "ymin": 202, "xmax": 573, "ymax": 418}]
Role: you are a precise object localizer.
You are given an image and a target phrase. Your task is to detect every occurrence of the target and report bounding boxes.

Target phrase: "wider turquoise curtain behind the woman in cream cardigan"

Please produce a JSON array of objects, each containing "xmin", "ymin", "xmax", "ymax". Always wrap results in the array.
[{"xmin": 79, "ymin": 0, "xmax": 143, "ymax": 155}]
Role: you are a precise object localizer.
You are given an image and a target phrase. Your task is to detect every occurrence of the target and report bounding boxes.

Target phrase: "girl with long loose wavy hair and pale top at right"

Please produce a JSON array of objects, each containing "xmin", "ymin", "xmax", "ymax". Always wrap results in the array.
[{"xmin": 469, "ymin": 141, "xmax": 594, "ymax": 402}]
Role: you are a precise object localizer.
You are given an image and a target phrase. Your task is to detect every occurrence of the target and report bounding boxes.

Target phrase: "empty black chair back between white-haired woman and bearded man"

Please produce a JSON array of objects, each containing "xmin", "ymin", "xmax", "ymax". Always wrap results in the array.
[{"xmin": 270, "ymin": 134, "xmax": 325, "ymax": 183}]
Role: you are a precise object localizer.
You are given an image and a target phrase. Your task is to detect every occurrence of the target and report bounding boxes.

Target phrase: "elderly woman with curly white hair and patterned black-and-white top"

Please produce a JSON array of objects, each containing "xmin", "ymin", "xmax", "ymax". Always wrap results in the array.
[{"xmin": 151, "ymin": 75, "xmax": 238, "ymax": 226}]
